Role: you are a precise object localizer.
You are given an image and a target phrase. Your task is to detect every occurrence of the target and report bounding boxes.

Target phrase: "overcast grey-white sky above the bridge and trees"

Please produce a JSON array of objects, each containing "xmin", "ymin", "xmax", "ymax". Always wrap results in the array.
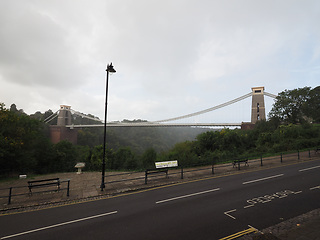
[{"xmin": 0, "ymin": 0, "xmax": 320, "ymax": 123}]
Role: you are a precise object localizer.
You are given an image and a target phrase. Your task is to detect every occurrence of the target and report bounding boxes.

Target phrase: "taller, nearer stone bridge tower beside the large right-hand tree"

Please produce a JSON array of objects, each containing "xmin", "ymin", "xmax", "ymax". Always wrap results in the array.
[{"xmin": 251, "ymin": 87, "xmax": 266, "ymax": 124}]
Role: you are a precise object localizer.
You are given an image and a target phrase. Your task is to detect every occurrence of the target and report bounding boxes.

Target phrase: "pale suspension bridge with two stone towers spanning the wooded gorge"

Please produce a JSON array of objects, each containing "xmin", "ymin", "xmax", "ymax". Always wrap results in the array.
[{"xmin": 44, "ymin": 87, "xmax": 277, "ymax": 129}]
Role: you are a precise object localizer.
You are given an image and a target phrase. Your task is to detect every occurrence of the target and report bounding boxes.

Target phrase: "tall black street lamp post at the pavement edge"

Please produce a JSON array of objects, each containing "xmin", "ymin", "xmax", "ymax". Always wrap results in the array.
[{"xmin": 100, "ymin": 63, "xmax": 116, "ymax": 191}]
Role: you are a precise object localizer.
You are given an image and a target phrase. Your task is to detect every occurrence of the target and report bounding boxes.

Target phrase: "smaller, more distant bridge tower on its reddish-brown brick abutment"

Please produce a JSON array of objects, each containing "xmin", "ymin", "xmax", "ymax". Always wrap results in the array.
[{"xmin": 50, "ymin": 105, "xmax": 78, "ymax": 144}]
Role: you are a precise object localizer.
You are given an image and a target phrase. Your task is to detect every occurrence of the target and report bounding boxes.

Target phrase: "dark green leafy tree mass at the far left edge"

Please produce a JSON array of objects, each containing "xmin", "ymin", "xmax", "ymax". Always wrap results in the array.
[{"xmin": 0, "ymin": 104, "xmax": 51, "ymax": 173}]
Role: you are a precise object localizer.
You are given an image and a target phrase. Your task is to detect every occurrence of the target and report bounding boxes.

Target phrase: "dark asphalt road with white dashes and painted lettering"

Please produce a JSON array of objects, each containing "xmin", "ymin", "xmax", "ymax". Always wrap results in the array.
[{"xmin": 0, "ymin": 160, "xmax": 320, "ymax": 240}]
